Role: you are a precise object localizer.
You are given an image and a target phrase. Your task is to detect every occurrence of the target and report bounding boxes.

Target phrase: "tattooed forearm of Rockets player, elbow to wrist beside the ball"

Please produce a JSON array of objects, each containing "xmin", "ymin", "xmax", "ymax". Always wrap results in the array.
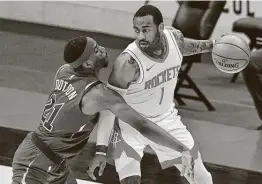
[{"xmin": 183, "ymin": 38, "xmax": 213, "ymax": 56}]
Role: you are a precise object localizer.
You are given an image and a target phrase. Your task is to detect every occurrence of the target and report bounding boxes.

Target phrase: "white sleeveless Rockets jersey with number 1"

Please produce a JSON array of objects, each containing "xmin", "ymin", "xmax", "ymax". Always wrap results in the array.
[{"xmin": 123, "ymin": 29, "xmax": 182, "ymax": 117}]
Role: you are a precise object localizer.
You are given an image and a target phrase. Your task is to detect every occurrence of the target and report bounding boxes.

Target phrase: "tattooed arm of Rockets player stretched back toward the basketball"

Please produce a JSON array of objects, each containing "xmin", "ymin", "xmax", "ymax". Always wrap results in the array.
[{"xmin": 167, "ymin": 27, "xmax": 213, "ymax": 56}]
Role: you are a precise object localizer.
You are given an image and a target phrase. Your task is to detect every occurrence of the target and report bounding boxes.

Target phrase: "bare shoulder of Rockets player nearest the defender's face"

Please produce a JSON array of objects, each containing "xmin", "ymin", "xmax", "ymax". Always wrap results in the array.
[{"xmin": 108, "ymin": 52, "xmax": 140, "ymax": 89}]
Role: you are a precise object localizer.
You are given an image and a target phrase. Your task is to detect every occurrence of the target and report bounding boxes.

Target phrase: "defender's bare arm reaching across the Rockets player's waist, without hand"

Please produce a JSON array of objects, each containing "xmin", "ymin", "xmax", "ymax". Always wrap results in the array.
[{"xmin": 82, "ymin": 84, "xmax": 189, "ymax": 152}]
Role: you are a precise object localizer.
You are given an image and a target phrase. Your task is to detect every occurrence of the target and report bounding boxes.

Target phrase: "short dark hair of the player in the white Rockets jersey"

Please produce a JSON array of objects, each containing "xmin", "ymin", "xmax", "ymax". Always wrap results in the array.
[{"xmin": 134, "ymin": 5, "xmax": 163, "ymax": 26}]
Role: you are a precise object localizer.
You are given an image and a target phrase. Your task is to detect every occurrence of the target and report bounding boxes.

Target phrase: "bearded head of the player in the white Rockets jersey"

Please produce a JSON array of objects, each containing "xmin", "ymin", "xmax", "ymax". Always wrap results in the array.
[{"xmin": 133, "ymin": 5, "xmax": 164, "ymax": 50}]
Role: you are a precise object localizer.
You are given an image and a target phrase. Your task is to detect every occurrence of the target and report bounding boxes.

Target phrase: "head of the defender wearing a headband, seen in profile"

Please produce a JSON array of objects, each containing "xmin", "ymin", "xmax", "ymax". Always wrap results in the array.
[{"xmin": 64, "ymin": 36, "xmax": 108, "ymax": 75}]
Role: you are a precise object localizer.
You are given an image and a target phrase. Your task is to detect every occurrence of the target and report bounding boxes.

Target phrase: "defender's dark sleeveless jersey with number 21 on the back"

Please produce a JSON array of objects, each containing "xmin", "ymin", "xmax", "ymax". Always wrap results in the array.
[{"xmin": 36, "ymin": 65, "xmax": 98, "ymax": 158}]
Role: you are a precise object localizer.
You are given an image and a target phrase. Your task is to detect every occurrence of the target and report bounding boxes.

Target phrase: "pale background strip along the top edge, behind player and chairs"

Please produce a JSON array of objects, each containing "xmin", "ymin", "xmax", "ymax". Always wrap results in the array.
[{"xmin": 0, "ymin": 0, "xmax": 262, "ymax": 38}]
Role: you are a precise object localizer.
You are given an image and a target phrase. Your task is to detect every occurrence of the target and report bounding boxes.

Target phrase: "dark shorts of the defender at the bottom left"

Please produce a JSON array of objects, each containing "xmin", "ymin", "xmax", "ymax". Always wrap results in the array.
[{"xmin": 12, "ymin": 133, "xmax": 77, "ymax": 184}]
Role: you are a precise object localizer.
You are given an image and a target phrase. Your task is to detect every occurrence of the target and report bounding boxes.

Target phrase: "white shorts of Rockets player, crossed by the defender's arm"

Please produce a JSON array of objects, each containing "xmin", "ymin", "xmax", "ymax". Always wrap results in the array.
[{"xmin": 110, "ymin": 105, "xmax": 194, "ymax": 180}]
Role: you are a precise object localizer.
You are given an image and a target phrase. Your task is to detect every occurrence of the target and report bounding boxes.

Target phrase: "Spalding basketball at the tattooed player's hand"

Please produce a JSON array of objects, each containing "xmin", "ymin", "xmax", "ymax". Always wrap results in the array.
[{"xmin": 212, "ymin": 34, "xmax": 250, "ymax": 74}]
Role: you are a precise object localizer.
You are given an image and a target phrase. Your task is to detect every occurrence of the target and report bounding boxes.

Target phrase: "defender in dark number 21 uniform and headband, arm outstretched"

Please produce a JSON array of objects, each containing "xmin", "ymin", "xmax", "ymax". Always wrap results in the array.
[{"xmin": 12, "ymin": 37, "xmax": 191, "ymax": 184}]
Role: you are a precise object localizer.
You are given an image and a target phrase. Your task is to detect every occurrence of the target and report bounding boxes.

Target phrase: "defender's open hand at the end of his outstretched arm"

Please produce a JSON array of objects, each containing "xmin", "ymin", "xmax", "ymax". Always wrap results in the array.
[{"xmin": 180, "ymin": 151, "xmax": 195, "ymax": 183}]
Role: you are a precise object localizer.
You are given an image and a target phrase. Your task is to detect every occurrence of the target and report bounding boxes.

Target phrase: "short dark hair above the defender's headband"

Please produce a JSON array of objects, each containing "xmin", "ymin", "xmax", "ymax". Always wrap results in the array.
[{"xmin": 64, "ymin": 36, "xmax": 87, "ymax": 63}]
